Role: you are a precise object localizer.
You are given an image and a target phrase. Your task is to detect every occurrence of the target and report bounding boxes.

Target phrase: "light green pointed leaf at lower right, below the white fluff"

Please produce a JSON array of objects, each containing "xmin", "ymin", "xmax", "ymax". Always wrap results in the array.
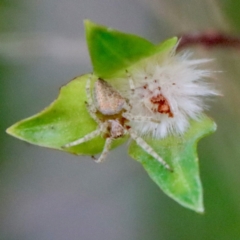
[{"xmin": 129, "ymin": 116, "xmax": 216, "ymax": 213}]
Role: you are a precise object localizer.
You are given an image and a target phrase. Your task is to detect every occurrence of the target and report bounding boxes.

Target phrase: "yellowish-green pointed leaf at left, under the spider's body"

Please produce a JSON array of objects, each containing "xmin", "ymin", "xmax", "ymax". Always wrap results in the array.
[{"xmin": 7, "ymin": 75, "xmax": 124, "ymax": 155}]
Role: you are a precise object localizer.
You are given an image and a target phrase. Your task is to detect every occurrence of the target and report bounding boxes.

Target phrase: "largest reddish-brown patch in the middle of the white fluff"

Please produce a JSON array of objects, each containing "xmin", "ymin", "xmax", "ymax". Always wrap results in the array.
[{"xmin": 150, "ymin": 94, "xmax": 173, "ymax": 117}]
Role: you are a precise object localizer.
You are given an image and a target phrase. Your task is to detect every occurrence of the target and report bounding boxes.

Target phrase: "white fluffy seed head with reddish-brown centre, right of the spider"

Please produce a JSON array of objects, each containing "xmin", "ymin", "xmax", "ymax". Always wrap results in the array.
[{"xmin": 111, "ymin": 47, "xmax": 219, "ymax": 139}]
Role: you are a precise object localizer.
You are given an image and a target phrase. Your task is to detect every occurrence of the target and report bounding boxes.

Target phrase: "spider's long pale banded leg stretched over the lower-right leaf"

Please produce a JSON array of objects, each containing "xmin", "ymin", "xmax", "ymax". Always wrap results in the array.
[{"xmin": 128, "ymin": 130, "xmax": 172, "ymax": 171}]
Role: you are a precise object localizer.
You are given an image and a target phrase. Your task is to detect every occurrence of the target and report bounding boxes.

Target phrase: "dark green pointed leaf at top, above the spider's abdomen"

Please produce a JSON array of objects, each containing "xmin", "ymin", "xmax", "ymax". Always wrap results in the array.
[{"xmin": 85, "ymin": 20, "xmax": 177, "ymax": 78}]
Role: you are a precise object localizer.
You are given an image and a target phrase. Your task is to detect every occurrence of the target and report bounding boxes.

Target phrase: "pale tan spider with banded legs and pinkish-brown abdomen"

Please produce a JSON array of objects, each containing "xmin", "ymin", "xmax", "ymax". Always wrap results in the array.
[{"xmin": 63, "ymin": 77, "xmax": 171, "ymax": 171}]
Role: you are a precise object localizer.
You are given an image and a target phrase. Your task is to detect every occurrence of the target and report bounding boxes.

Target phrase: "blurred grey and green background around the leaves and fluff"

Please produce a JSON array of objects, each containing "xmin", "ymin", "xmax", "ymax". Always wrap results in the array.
[{"xmin": 0, "ymin": 0, "xmax": 240, "ymax": 240}]
